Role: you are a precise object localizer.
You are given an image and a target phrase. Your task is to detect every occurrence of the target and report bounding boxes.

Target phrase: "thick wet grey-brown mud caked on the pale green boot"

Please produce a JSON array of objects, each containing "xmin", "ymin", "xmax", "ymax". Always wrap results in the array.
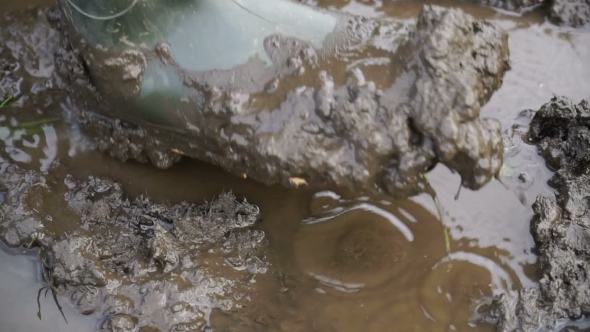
[{"xmin": 57, "ymin": 5, "xmax": 509, "ymax": 197}]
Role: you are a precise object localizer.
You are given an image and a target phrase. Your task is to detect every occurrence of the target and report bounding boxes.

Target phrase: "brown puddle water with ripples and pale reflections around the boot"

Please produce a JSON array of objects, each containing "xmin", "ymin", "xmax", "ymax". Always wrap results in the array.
[{"xmin": 0, "ymin": 0, "xmax": 590, "ymax": 332}]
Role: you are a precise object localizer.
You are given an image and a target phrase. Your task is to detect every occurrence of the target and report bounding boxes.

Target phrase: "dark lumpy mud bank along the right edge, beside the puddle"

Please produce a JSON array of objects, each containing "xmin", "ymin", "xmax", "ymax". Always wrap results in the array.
[{"xmin": 492, "ymin": 97, "xmax": 590, "ymax": 331}]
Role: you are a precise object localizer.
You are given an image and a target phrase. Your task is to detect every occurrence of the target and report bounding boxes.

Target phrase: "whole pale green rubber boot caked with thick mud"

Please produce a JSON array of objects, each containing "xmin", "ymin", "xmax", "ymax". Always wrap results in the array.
[{"xmin": 59, "ymin": 0, "xmax": 508, "ymax": 197}]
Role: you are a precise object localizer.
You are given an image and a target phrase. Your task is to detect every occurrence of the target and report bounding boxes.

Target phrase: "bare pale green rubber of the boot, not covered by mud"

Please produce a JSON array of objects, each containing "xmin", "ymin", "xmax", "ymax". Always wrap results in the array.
[{"xmin": 59, "ymin": 0, "xmax": 336, "ymax": 129}]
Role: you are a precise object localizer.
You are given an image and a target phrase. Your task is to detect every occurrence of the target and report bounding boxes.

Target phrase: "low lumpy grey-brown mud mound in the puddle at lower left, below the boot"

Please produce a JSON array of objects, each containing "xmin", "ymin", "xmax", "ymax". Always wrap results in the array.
[{"xmin": 0, "ymin": 166, "xmax": 268, "ymax": 332}]
